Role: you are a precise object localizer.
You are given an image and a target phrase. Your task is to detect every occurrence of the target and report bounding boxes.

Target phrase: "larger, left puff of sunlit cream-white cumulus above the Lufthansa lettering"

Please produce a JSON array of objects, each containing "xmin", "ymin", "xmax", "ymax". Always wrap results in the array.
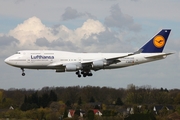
[{"xmin": 9, "ymin": 17, "xmax": 55, "ymax": 46}]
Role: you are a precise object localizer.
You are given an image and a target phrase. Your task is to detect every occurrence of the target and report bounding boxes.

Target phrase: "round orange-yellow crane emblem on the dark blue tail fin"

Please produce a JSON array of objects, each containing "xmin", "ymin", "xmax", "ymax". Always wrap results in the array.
[{"xmin": 153, "ymin": 35, "xmax": 165, "ymax": 48}]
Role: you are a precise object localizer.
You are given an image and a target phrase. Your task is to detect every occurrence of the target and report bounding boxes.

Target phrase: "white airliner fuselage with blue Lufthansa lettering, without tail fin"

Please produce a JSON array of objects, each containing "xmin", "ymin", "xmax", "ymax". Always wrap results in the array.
[{"xmin": 5, "ymin": 50, "xmax": 166, "ymax": 72}]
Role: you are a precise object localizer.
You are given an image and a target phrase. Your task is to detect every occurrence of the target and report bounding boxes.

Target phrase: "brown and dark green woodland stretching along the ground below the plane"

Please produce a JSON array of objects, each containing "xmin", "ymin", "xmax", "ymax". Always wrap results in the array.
[{"xmin": 0, "ymin": 84, "xmax": 180, "ymax": 120}]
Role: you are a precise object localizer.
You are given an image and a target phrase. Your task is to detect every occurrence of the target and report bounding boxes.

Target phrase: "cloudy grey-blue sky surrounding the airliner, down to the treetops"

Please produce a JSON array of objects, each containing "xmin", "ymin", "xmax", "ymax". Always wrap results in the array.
[{"xmin": 0, "ymin": 0, "xmax": 180, "ymax": 89}]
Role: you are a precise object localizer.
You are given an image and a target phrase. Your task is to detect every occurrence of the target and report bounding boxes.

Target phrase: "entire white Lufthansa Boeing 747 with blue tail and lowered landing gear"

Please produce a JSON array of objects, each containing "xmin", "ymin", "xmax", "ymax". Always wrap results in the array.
[{"xmin": 5, "ymin": 29, "xmax": 172, "ymax": 77}]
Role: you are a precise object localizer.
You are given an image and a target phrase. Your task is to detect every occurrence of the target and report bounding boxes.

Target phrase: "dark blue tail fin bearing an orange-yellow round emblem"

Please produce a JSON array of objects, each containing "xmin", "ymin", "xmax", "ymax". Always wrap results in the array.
[{"xmin": 139, "ymin": 29, "xmax": 171, "ymax": 53}]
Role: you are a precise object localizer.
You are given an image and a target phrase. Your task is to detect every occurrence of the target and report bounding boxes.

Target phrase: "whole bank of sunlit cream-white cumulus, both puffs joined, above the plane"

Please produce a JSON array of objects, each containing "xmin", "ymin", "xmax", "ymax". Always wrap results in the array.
[{"xmin": 9, "ymin": 17, "xmax": 105, "ymax": 49}]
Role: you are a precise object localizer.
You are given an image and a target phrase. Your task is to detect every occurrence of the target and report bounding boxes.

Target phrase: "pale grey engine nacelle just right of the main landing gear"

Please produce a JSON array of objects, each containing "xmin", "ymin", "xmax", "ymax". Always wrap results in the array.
[{"xmin": 92, "ymin": 59, "xmax": 108, "ymax": 68}]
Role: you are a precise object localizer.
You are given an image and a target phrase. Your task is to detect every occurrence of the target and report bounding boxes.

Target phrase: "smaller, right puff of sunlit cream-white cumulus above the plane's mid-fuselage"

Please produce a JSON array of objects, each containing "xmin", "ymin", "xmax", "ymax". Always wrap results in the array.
[{"xmin": 52, "ymin": 19, "xmax": 105, "ymax": 47}]
